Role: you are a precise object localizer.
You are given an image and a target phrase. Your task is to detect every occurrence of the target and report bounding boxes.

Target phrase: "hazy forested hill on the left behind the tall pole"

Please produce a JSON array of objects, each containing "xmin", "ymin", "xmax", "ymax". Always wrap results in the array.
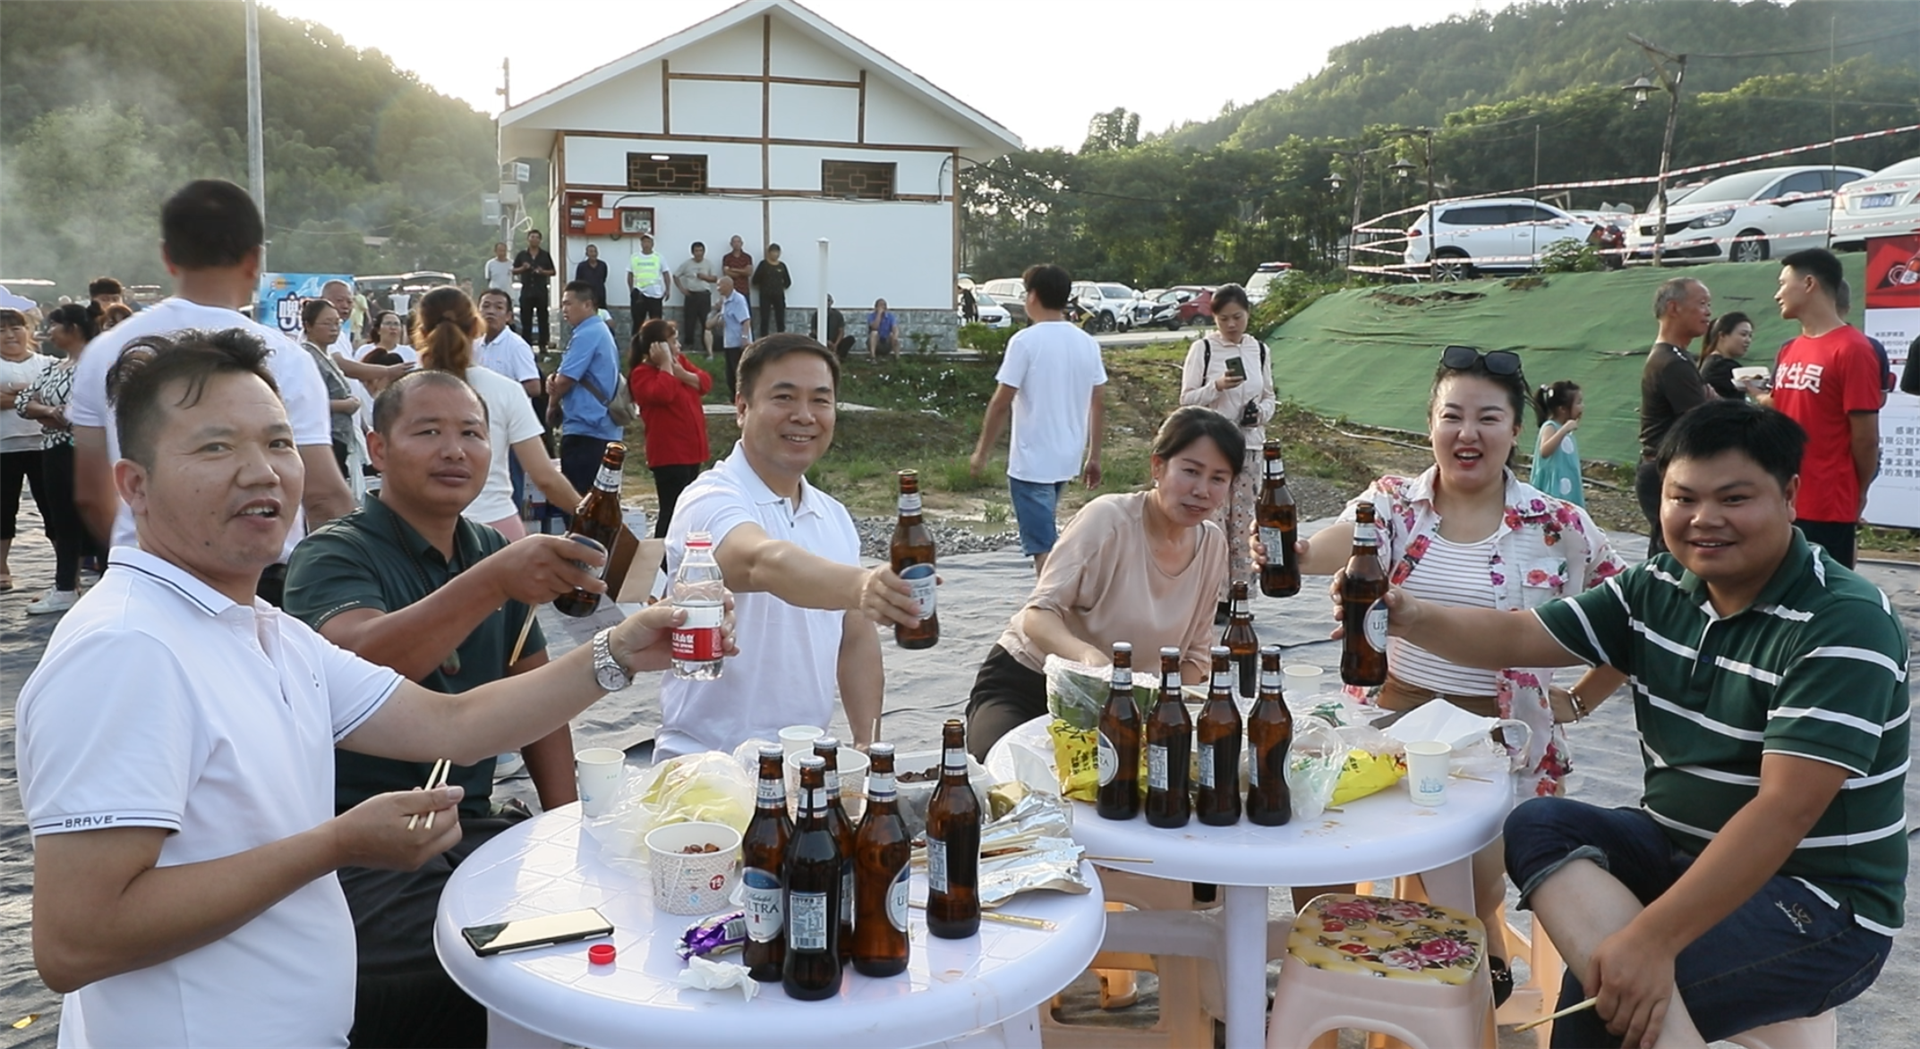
[{"xmin": 0, "ymin": 0, "xmax": 497, "ymax": 294}]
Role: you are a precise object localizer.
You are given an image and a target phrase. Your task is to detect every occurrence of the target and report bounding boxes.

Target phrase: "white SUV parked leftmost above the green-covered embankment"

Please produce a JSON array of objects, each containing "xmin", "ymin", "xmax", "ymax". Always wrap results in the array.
[{"xmin": 1404, "ymin": 196, "xmax": 1601, "ymax": 281}]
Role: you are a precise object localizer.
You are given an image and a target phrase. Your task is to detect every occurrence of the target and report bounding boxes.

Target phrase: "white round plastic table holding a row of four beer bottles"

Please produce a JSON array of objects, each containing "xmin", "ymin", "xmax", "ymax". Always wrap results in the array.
[{"xmin": 989, "ymin": 715, "xmax": 1513, "ymax": 1049}]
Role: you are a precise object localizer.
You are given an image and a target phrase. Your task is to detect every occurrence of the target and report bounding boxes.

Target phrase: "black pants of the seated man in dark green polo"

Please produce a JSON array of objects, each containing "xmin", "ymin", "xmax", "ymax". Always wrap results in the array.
[{"xmin": 340, "ymin": 818, "xmax": 518, "ymax": 1049}]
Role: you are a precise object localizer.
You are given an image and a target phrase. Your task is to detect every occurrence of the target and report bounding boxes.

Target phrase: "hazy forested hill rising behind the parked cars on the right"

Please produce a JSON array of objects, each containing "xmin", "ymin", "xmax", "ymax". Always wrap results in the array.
[{"xmin": 1164, "ymin": 0, "xmax": 1920, "ymax": 150}]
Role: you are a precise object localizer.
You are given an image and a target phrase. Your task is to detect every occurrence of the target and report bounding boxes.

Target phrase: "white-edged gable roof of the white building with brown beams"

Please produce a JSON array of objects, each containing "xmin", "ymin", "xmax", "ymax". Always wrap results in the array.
[{"xmin": 499, "ymin": 0, "xmax": 1025, "ymax": 154}]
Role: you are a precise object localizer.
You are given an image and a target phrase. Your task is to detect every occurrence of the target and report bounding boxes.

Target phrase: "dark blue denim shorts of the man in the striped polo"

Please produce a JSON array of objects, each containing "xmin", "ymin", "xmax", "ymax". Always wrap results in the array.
[{"xmin": 1505, "ymin": 797, "xmax": 1893, "ymax": 1049}]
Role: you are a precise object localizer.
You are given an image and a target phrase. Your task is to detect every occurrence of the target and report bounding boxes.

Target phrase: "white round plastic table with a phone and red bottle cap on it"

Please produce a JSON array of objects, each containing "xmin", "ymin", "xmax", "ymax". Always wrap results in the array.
[{"xmin": 434, "ymin": 805, "xmax": 1106, "ymax": 1049}]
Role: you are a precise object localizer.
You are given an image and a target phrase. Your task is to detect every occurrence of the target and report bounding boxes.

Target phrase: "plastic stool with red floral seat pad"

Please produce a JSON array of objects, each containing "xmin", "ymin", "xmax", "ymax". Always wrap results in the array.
[{"xmin": 1267, "ymin": 893, "xmax": 1496, "ymax": 1049}]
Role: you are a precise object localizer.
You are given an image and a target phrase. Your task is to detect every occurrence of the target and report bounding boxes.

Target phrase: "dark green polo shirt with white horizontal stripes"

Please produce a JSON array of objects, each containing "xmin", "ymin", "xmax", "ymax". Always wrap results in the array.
[{"xmin": 1534, "ymin": 528, "xmax": 1910, "ymax": 936}]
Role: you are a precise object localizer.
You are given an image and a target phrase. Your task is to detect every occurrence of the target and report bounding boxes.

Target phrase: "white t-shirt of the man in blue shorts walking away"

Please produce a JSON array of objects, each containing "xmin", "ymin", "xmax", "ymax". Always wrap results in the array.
[{"xmin": 995, "ymin": 321, "xmax": 1106, "ymax": 484}]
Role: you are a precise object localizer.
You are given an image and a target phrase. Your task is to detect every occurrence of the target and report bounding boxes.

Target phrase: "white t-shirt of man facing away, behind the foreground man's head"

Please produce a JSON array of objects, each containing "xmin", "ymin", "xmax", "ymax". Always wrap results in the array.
[{"xmin": 67, "ymin": 298, "xmax": 334, "ymax": 561}]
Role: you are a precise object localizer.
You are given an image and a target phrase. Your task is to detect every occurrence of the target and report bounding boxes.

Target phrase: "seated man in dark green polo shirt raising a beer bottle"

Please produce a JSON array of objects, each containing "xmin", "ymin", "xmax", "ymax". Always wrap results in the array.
[{"xmin": 286, "ymin": 371, "xmax": 610, "ymax": 1045}]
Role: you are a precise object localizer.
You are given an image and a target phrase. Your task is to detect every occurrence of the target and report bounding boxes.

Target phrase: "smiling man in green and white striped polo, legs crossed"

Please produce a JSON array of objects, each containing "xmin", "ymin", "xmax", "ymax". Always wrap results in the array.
[{"xmin": 1388, "ymin": 402, "xmax": 1908, "ymax": 1047}]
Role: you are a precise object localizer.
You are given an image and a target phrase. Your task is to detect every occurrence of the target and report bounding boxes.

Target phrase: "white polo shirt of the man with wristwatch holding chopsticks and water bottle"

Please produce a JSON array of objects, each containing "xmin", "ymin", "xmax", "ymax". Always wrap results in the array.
[{"xmin": 15, "ymin": 541, "xmax": 401, "ymax": 1047}]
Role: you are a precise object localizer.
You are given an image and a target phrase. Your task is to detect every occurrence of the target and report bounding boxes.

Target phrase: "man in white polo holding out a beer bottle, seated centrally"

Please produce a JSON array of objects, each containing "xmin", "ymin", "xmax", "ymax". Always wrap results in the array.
[{"xmin": 653, "ymin": 334, "xmax": 920, "ymax": 761}]
